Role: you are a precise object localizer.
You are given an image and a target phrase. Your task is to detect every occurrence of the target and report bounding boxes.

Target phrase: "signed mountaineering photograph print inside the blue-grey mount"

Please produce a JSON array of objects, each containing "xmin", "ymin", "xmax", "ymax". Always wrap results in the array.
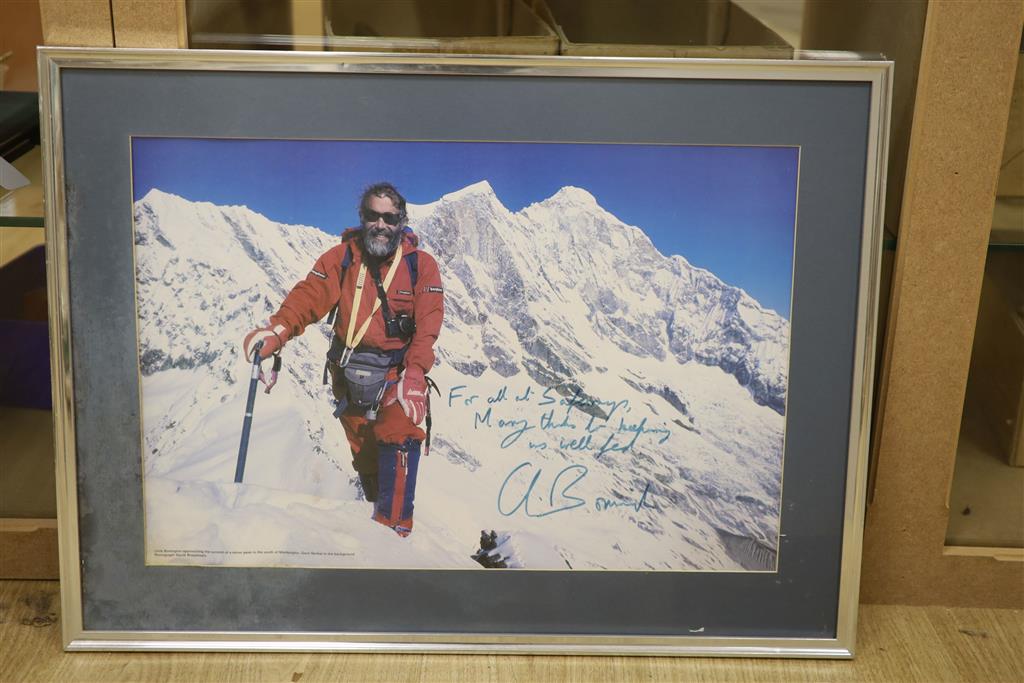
[{"xmin": 132, "ymin": 137, "xmax": 800, "ymax": 572}]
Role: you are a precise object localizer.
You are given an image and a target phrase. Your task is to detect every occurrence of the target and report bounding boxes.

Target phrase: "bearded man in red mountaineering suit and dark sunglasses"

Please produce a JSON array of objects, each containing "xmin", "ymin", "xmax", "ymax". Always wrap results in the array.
[{"xmin": 243, "ymin": 182, "xmax": 444, "ymax": 537}]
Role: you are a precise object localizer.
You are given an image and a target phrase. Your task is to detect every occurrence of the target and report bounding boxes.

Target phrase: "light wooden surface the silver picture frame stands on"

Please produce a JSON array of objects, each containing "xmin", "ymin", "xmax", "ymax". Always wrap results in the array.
[{"xmin": 0, "ymin": 581, "xmax": 1024, "ymax": 683}]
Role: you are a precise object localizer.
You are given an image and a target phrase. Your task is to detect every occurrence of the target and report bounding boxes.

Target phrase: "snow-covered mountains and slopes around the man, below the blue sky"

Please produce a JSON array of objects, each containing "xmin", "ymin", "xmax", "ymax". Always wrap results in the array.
[{"xmin": 135, "ymin": 182, "xmax": 788, "ymax": 570}]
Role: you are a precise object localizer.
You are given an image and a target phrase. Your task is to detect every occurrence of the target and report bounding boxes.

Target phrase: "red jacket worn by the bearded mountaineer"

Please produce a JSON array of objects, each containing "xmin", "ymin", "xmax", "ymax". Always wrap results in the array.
[{"xmin": 270, "ymin": 228, "xmax": 444, "ymax": 373}]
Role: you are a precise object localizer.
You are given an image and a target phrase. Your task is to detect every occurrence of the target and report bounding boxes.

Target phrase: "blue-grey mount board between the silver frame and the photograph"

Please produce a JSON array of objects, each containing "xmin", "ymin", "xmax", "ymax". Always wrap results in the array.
[{"xmin": 60, "ymin": 69, "xmax": 870, "ymax": 638}]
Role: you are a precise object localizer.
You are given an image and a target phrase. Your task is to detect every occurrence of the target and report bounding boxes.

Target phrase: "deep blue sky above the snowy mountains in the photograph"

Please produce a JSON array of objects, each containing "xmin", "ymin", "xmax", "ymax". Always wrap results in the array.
[{"xmin": 132, "ymin": 137, "xmax": 799, "ymax": 318}]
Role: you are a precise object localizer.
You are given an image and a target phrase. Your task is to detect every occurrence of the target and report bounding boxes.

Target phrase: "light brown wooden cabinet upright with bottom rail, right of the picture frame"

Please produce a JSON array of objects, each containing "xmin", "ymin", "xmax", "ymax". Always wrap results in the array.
[{"xmin": 861, "ymin": 1, "xmax": 1024, "ymax": 607}]
